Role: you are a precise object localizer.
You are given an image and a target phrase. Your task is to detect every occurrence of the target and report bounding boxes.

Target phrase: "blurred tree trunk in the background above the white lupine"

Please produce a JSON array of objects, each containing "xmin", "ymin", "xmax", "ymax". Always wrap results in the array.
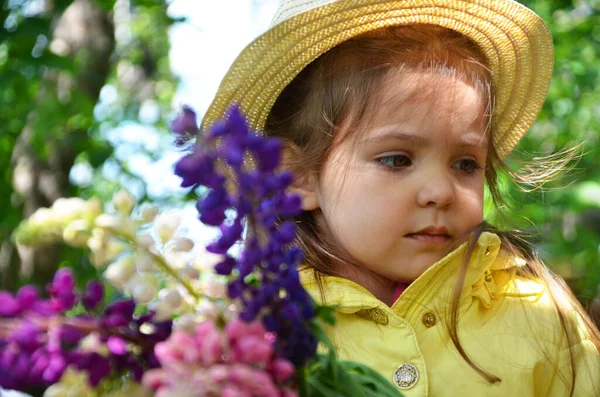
[{"xmin": 0, "ymin": 0, "xmax": 115, "ymax": 289}]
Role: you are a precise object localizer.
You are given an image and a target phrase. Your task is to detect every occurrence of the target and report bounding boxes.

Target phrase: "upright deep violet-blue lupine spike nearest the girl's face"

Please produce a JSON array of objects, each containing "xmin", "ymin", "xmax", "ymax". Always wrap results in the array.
[{"xmin": 175, "ymin": 107, "xmax": 317, "ymax": 365}]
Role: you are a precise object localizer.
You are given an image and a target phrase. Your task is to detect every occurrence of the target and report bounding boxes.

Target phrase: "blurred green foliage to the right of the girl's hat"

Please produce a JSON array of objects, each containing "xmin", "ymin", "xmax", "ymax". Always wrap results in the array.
[{"xmin": 504, "ymin": 0, "xmax": 600, "ymax": 304}]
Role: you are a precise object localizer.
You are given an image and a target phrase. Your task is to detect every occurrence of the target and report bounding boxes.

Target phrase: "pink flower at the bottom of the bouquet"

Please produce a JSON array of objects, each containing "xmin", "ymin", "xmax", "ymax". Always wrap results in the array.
[{"xmin": 142, "ymin": 319, "xmax": 296, "ymax": 397}]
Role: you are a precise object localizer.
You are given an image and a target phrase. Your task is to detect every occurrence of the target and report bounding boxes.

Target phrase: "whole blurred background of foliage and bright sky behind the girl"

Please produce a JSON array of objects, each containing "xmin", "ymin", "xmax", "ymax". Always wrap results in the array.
[{"xmin": 0, "ymin": 0, "xmax": 600, "ymax": 322}]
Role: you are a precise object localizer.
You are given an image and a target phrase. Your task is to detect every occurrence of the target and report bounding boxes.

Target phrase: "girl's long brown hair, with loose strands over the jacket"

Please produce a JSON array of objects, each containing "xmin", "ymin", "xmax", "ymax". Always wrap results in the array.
[{"xmin": 265, "ymin": 25, "xmax": 600, "ymax": 393}]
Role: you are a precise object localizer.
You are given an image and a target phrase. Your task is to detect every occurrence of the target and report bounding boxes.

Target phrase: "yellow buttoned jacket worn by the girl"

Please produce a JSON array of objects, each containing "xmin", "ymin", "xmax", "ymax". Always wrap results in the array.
[{"xmin": 301, "ymin": 233, "xmax": 600, "ymax": 397}]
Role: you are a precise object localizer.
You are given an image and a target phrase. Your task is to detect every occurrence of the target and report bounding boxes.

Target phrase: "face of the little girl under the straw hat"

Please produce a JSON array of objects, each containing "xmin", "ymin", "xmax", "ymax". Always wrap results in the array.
[{"xmin": 316, "ymin": 73, "xmax": 488, "ymax": 281}]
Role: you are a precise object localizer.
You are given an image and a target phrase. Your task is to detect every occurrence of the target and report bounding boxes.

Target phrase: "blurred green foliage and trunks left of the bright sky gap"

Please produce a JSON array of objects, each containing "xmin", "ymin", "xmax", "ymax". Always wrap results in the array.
[{"xmin": 0, "ymin": 0, "xmax": 178, "ymax": 289}]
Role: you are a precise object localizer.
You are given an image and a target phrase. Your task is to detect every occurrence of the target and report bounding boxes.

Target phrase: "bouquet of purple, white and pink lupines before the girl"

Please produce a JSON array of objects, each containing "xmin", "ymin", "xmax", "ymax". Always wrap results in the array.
[{"xmin": 0, "ymin": 107, "xmax": 400, "ymax": 397}]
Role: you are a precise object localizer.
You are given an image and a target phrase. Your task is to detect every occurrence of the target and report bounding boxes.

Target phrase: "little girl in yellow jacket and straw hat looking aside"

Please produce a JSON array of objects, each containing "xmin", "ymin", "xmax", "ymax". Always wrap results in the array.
[{"xmin": 202, "ymin": 0, "xmax": 600, "ymax": 396}]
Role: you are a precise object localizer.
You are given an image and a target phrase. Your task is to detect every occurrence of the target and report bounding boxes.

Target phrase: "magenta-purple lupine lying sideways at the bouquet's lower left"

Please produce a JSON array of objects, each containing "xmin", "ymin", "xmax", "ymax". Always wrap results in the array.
[{"xmin": 0, "ymin": 269, "xmax": 172, "ymax": 391}]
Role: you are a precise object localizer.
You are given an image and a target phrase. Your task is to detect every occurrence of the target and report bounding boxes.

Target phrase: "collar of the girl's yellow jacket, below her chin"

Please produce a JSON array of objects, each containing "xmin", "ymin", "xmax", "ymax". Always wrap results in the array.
[{"xmin": 300, "ymin": 232, "xmax": 539, "ymax": 318}]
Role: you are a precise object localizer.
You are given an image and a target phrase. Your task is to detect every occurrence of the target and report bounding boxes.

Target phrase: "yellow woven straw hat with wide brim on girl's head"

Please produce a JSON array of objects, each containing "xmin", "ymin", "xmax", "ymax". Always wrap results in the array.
[{"xmin": 201, "ymin": 0, "xmax": 554, "ymax": 157}]
